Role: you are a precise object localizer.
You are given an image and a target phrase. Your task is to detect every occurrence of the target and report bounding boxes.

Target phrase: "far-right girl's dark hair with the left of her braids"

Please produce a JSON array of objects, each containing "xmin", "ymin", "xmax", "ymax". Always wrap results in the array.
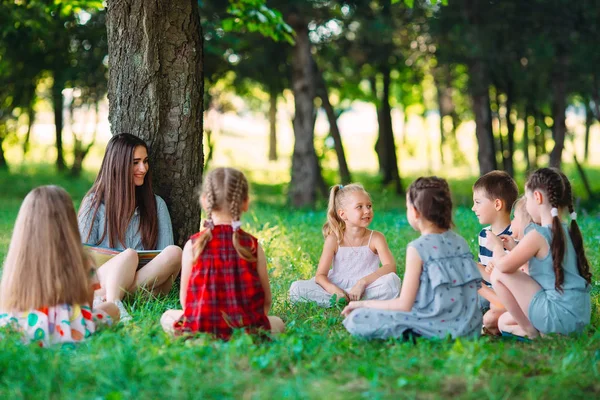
[{"xmin": 525, "ymin": 168, "xmax": 566, "ymax": 292}]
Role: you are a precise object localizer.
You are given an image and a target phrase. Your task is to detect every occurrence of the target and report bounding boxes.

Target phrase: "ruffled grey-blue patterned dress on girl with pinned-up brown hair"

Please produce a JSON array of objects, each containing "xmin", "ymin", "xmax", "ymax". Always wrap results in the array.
[{"xmin": 344, "ymin": 231, "xmax": 482, "ymax": 339}]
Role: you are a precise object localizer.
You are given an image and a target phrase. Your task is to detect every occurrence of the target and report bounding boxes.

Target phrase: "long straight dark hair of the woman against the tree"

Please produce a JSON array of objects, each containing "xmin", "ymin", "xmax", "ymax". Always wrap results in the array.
[{"xmin": 80, "ymin": 133, "xmax": 158, "ymax": 249}]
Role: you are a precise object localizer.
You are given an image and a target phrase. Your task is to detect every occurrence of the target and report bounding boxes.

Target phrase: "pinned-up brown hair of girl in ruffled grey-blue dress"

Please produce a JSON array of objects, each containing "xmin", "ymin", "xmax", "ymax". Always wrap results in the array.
[{"xmin": 408, "ymin": 176, "xmax": 453, "ymax": 229}]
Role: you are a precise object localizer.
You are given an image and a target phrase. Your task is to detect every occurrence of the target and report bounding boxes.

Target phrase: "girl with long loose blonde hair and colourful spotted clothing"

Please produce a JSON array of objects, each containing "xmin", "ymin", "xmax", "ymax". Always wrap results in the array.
[{"xmin": 0, "ymin": 186, "xmax": 119, "ymax": 347}]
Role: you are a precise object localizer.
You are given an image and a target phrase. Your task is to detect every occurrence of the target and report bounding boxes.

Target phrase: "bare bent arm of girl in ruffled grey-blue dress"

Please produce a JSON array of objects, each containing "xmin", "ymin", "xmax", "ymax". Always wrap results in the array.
[{"xmin": 342, "ymin": 246, "xmax": 423, "ymax": 316}]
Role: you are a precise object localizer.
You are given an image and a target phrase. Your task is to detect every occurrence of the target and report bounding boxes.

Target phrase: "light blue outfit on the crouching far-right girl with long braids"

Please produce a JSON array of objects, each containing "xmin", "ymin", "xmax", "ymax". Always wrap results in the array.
[{"xmin": 525, "ymin": 223, "xmax": 592, "ymax": 334}]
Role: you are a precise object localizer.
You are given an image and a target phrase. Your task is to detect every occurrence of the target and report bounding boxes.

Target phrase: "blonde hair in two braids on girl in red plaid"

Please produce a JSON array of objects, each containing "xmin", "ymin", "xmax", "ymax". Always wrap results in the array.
[{"xmin": 193, "ymin": 168, "xmax": 256, "ymax": 261}]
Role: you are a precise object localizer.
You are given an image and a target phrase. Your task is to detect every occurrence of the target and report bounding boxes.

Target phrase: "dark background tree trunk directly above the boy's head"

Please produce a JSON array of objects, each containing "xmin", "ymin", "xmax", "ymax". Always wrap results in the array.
[{"xmin": 469, "ymin": 61, "xmax": 497, "ymax": 175}]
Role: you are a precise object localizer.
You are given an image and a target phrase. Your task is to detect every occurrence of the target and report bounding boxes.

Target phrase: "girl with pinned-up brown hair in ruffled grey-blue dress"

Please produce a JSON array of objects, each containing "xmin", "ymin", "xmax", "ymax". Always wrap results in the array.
[{"xmin": 342, "ymin": 177, "xmax": 482, "ymax": 339}]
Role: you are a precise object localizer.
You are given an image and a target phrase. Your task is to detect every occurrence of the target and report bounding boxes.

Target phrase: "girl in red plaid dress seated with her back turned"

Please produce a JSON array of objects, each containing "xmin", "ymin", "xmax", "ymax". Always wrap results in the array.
[{"xmin": 161, "ymin": 168, "xmax": 284, "ymax": 340}]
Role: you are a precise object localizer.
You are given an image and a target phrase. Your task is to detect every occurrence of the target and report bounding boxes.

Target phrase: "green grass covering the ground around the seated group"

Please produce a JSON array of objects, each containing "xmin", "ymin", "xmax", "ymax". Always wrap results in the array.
[{"xmin": 0, "ymin": 167, "xmax": 600, "ymax": 399}]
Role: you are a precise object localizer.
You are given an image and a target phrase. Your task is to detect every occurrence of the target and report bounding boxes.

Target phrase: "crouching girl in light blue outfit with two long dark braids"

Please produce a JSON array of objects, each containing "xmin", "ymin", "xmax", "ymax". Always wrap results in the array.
[{"xmin": 488, "ymin": 168, "xmax": 591, "ymax": 338}]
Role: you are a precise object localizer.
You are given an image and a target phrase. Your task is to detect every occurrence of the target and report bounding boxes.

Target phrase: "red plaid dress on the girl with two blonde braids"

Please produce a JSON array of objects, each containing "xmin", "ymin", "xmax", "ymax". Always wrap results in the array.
[{"xmin": 175, "ymin": 225, "xmax": 271, "ymax": 340}]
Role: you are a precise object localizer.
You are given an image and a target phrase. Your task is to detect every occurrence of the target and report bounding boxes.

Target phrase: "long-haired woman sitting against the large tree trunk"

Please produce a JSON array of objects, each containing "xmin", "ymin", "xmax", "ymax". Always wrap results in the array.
[{"xmin": 79, "ymin": 133, "xmax": 181, "ymax": 318}]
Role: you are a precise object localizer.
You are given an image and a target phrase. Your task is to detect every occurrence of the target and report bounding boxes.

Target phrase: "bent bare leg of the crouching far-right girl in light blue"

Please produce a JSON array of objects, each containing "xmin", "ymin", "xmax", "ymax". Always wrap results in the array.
[{"xmin": 492, "ymin": 269, "xmax": 542, "ymax": 339}]
